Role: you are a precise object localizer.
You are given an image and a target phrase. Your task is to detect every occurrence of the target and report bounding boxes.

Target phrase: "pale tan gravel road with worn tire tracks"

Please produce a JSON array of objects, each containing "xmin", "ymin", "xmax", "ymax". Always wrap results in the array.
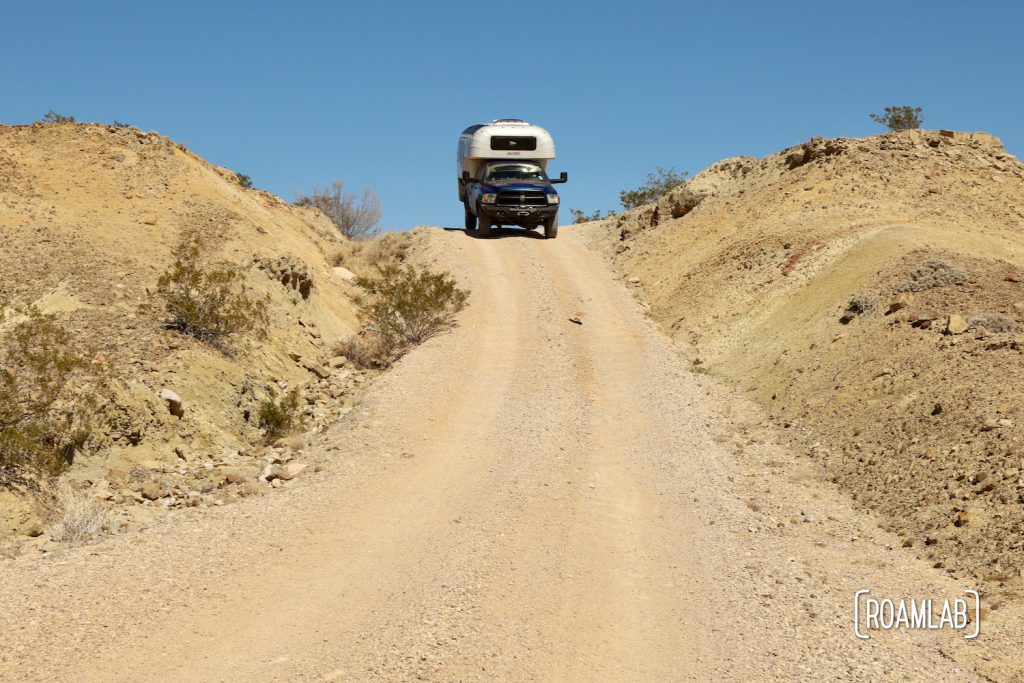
[{"xmin": 0, "ymin": 229, "xmax": 991, "ymax": 681}]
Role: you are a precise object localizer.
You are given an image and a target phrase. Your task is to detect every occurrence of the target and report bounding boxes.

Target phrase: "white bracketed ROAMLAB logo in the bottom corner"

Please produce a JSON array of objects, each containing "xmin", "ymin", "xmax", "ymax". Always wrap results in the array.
[{"xmin": 853, "ymin": 588, "xmax": 981, "ymax": 640}]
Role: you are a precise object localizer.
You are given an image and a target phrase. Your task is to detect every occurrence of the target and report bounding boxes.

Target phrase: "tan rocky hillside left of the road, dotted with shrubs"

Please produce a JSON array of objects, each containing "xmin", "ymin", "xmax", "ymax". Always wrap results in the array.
[{"xmin": 0, "ymin": 124, "xmax": 380, "ymax": 551}]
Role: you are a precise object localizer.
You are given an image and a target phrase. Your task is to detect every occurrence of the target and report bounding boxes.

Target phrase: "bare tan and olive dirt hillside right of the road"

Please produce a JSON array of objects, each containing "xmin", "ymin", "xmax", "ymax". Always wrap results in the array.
[{"xmin": 587, "ymin": 130, "xmax": 1024, "ymax": 593}]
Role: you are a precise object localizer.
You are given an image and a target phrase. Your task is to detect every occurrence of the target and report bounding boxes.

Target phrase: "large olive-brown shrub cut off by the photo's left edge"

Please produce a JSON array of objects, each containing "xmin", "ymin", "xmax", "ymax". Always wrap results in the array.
[{"xmin": 0, "ymin": 307, "xmax": 103, "ymax": 483}]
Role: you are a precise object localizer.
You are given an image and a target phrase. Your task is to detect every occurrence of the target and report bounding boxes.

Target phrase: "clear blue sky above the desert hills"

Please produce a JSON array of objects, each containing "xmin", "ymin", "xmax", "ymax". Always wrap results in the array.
[{"xmin": 0, "ymin": 0, "xmax": 1024, "ymax": 229}]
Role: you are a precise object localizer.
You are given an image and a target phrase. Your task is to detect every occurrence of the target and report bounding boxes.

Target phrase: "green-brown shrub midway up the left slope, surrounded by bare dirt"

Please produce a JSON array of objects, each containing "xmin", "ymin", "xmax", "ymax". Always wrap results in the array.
[{"xmin": 157, "ymin": 231, "xmax": 269, "ymax": 349}]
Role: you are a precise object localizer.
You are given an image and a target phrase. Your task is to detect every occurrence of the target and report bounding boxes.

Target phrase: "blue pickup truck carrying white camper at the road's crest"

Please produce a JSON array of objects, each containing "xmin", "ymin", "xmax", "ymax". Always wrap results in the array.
[{"xmin": 457, "ymin": 119, "xmax": 568, "ymax": 239}]
